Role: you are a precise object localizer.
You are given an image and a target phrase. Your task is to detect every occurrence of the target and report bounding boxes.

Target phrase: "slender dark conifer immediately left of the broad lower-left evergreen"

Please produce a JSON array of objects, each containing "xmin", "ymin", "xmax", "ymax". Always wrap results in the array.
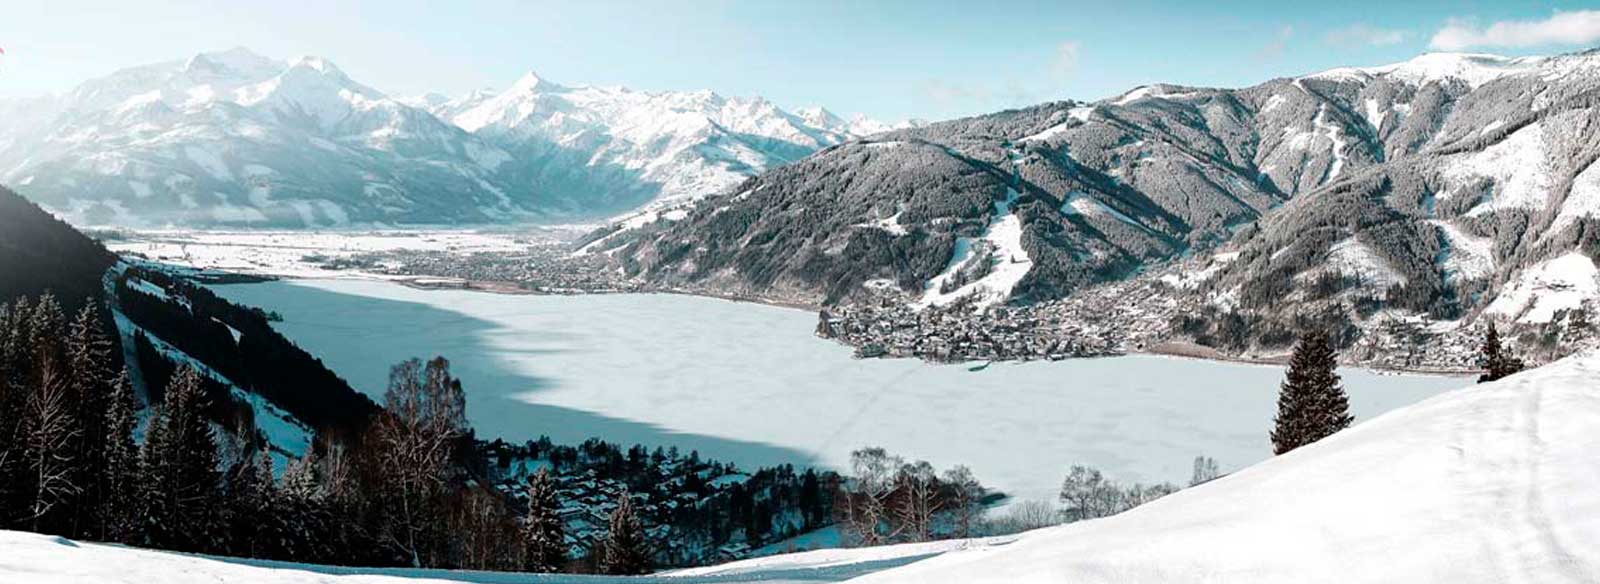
[{"xmin": 96, "ymin": 368, "xmax": 139, "ymax": 544}]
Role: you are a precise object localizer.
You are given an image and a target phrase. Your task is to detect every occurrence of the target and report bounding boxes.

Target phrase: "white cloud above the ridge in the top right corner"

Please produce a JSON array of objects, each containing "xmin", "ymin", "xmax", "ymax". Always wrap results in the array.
[{"xmin": 1429, "ymin": 10, "xmax": 1600, "ymax": 51}]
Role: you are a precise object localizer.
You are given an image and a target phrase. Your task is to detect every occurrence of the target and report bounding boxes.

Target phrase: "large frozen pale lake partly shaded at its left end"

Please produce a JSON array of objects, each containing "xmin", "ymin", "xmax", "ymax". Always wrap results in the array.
[{"xmin": 216, "ymin": 280, "xmax": 1470, "ymax": 501}]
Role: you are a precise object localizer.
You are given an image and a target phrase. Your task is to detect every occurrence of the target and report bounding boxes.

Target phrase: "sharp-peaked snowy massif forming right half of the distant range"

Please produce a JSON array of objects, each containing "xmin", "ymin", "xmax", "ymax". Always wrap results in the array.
[{"xmin": 427, "ymin": 72, "xmax": 915, "ymax": 210}]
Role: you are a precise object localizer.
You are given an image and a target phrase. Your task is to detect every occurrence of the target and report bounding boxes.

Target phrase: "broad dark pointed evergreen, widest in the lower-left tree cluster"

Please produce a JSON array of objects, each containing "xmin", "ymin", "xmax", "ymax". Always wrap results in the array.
[{"xmin": 142, "ymin": 365, "xmax": 222, "ymax": 552}]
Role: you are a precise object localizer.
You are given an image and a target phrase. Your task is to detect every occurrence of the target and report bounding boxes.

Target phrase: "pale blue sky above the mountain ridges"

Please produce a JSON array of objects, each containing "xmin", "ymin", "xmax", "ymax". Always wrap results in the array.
[{"xmin": 0, "ymin": 0, "xmax": 1600, "ymax": 120}]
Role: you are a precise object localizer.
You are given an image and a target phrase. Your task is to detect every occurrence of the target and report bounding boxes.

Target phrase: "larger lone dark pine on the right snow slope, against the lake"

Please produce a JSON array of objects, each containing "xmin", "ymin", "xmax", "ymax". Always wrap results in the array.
[{"xmin": 1272, "ymin": 333, "xmax": 1354, "ymax": 454}]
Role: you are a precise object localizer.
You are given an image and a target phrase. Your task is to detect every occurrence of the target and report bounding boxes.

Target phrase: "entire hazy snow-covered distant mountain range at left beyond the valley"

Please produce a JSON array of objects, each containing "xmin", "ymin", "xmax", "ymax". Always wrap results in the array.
[{"xmin": 0, "ymin": 48, "xmax": 891, "ymax": 227}]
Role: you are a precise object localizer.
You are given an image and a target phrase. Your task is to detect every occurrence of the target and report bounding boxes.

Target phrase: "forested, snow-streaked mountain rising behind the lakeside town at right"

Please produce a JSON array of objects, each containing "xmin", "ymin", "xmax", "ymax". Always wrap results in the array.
[{"xmin": 617, "ymin": 51, "xmax": 1600, "ymax": 332}]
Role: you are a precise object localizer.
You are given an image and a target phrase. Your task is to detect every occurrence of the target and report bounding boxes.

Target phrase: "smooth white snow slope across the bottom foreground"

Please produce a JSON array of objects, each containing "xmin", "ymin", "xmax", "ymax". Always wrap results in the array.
[{"xmin": 0, "ymin": 354, "xmax": 1600, "ymax": 584}]
